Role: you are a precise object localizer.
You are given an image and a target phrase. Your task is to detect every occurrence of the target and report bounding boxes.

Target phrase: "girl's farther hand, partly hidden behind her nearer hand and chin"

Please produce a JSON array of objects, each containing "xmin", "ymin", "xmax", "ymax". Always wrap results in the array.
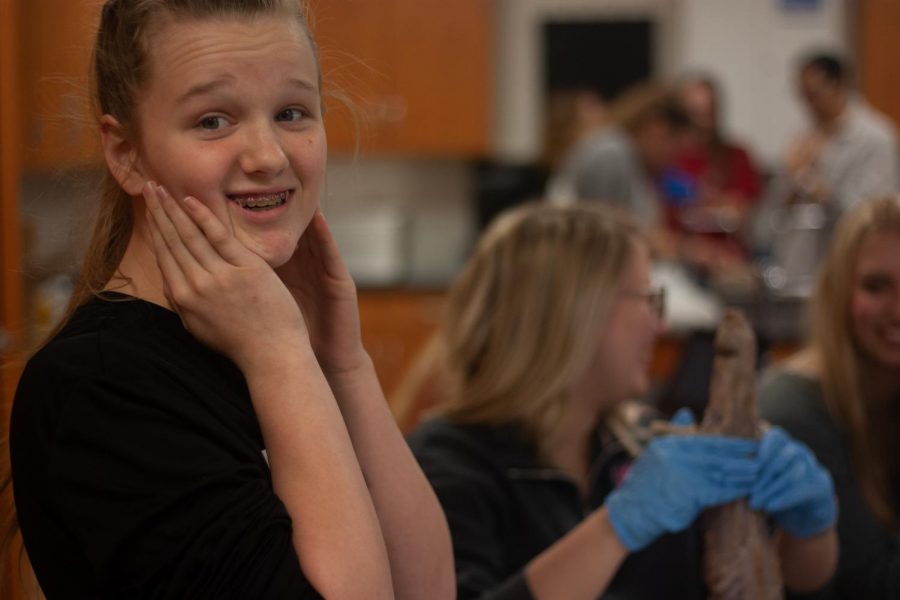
[{"xmin": 275, "ymin": 213, "xmax": 369, "ymax": 378}]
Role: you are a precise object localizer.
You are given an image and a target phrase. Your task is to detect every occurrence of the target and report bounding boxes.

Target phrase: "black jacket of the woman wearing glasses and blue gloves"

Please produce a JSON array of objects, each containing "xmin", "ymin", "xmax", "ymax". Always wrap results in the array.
[{"xmin": 408, "ymin": 419, "xmax": 706, "ymax": 600}]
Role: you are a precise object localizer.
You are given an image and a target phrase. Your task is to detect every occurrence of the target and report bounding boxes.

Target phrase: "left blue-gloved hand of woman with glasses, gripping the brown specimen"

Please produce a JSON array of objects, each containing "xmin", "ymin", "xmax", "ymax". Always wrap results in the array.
[{"xmin": 606, "ymin": 413, "xmax": 760, "ymax": 552}]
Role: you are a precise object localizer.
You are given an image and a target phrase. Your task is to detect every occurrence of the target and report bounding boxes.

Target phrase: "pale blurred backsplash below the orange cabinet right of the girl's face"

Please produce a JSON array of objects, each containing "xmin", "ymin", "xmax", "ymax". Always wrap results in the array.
[{"xmin": 322, "ymin": 158, "xmax": 476, "ymax": 287}]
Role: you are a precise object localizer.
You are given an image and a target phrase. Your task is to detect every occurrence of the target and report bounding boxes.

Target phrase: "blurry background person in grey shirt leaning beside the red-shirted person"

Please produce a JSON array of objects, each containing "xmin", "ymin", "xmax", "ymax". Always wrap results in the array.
[{"xmin": 548, "ymin": 82, "xmax": 689, "ymax": 230}]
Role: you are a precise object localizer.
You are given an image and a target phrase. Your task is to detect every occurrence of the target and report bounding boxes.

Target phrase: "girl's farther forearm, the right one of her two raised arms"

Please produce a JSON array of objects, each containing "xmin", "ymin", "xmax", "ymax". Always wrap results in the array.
[{"xmin": 329, "ymin": 356, "xmax": 456, "ymax": 599}]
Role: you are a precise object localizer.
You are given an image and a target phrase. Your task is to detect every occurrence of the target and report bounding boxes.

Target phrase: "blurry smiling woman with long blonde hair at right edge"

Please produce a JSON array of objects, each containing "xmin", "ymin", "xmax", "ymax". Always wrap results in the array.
[{"xmin": 759, "ymin": 195, "xmax": 900, "ymax": 598}]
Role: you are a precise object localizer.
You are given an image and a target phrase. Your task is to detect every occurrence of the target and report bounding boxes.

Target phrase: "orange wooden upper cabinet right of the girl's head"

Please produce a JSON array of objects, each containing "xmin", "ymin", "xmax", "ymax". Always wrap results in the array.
[{"xmin": 312, "ymin": 0, "xmax": 490, "ymax": 157}]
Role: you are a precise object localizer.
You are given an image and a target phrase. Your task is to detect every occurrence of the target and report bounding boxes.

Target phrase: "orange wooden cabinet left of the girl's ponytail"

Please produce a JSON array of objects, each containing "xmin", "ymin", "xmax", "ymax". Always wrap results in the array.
[{"xmin": 19, "ymin": 0, "xmax": 100, "ymax": 171}]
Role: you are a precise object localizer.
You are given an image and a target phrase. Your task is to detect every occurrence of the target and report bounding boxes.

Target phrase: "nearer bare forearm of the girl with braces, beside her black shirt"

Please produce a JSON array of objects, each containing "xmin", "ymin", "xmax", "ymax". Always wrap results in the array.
[{"xmin": 244, "ymin": 346, "xmax": 392, "ymax": 598}]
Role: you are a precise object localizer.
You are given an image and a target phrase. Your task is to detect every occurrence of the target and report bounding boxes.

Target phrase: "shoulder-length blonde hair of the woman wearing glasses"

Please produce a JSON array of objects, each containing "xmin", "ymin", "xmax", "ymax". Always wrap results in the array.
[{"xmin": 440, "ymin": 204, "xmax": 645, "ymax": 449}]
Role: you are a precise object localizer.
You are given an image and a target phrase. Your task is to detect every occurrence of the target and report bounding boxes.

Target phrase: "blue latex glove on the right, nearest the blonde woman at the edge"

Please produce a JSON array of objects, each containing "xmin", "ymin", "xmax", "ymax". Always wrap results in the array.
[{"xmin": 750, "ymin": 427, "xmax": 837, "ymax": 538}]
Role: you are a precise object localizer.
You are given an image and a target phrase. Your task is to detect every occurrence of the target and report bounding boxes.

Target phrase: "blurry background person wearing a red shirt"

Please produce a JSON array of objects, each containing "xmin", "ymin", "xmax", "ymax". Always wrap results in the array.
[{"xmin": 662, "ymin": 74, "xmax": 761, "ymax": 269}]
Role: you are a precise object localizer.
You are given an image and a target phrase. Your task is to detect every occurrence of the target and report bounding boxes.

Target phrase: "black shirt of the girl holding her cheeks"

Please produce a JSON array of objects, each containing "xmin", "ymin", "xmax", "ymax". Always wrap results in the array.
[{"xmin": 10, "ymin": 293, "xmax": 320, "ymax": 600}]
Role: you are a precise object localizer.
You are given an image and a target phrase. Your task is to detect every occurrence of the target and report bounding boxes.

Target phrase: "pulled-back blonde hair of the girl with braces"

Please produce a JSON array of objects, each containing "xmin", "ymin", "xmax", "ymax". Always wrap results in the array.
[{"xmin": 0, "ymin": 0, "xmax": 321, "ymax": 595}]
